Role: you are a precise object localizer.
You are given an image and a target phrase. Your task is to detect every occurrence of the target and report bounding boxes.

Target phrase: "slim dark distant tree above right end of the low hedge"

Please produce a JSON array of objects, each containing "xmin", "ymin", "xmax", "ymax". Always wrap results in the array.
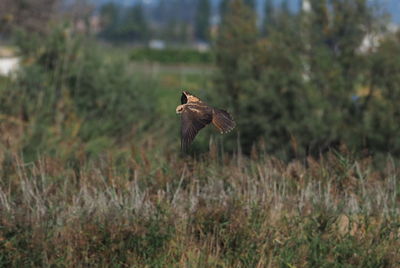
[{"xmin": 195, "ymin": 0, "xmax": 211, "ymax": 41}]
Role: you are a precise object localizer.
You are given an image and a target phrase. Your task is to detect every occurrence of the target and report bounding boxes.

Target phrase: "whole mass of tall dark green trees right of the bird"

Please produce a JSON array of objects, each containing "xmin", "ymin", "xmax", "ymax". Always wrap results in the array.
[{"xmin": 215, "ymin": 0, "xmax": 400, "ymax": 159}]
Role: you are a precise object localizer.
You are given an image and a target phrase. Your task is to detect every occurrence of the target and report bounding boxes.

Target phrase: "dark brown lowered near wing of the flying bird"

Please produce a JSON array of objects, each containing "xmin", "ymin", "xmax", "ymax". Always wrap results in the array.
[{"xmin": 181, "ymin": 107, "xmax": 212, "ymax": 151}]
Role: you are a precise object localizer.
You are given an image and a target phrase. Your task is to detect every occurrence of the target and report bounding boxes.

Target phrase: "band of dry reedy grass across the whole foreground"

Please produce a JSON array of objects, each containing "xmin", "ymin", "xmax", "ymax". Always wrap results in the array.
[{"xmin": 0, "ymin": 150, "xmax": 400, "ymax": 267}]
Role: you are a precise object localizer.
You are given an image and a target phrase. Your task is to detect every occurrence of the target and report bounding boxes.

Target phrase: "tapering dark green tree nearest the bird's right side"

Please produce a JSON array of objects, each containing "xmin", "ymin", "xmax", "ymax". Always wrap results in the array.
[{"xmin": 240, "ymin": 12, "xmax": 306, "ymax": 158}]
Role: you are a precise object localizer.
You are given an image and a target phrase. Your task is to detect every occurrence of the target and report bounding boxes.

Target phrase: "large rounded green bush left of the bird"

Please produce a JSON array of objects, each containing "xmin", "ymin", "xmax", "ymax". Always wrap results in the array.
[{"xmin": 0, "ymin": 27, "xmax": 153, "ymax": 157}]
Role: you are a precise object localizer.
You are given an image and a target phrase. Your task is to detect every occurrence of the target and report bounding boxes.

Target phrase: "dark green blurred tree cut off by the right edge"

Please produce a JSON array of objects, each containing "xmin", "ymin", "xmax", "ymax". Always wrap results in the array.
[{"xmin": 360, "ymin": 32, "xmax": 400, "ymax": 156}]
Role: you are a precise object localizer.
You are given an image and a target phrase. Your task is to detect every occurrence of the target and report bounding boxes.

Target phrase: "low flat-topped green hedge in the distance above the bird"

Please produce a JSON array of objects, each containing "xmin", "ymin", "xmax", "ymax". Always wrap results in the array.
[{"xmin": 131, "ymin": 48, "xmax": 213, "ymax": 64}]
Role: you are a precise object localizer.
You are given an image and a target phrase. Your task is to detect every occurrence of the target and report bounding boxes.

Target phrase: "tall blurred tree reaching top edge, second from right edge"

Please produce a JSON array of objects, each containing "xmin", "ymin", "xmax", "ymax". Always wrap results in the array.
[{"xmin": 303, "ymin": 0, "xmax": 373, "ymax": 151}]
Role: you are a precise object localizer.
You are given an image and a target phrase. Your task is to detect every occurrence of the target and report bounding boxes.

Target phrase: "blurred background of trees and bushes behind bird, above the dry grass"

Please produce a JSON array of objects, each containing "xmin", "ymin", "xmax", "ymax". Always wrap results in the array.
[{"xmin": 0, "ymin": 0, "xmax": 400, "ymax": 160}]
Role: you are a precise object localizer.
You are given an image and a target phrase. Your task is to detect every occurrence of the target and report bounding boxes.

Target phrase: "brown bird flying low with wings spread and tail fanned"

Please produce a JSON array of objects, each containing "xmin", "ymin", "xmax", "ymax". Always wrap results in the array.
[{"xmin": 176, "ymin": 91, "xmax": 236, "ymax": 151}]
